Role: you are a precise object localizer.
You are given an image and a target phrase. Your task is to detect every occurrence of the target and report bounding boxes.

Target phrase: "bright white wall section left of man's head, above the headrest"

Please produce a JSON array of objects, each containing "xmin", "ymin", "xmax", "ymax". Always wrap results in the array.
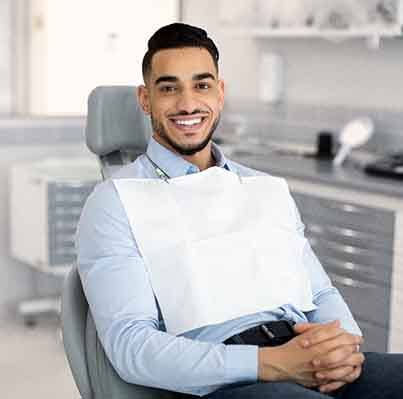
[{"xmin": 30, "ymin": 0, "xmax": 178, "ymax": 115}]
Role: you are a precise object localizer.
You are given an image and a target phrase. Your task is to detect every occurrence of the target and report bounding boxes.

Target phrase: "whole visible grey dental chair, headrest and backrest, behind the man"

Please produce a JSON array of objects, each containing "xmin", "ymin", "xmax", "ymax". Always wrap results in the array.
[{"xmin": 61, "ymin": 86, "xmax": 179, "ymax": 399}]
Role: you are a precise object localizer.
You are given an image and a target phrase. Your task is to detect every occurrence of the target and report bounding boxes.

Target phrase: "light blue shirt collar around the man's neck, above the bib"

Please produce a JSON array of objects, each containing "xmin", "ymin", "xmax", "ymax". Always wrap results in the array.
[{"xmin": 147, "ymin": 137, "xmax": 231, "ymax": 177}]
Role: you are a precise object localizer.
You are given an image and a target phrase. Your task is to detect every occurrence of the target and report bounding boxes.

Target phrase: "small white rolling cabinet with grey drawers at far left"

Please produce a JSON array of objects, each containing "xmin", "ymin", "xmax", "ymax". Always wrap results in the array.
[{"xmin": 9, "ymin": 157, "xmax": 100, "ymax": 325}]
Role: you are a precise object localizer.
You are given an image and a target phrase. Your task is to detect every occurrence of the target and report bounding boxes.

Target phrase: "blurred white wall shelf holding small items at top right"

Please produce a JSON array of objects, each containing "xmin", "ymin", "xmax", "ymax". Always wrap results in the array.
[{"xmin": 220, "ymin": 0, "xmax": 403, "ymax": 40}]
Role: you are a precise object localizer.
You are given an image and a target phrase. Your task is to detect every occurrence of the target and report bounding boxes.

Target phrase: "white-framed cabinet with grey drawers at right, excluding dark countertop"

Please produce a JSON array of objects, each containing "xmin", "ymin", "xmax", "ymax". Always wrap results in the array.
[{"xmin": 289, "ymin": 179, "xmax": 403, "ymax": 352}]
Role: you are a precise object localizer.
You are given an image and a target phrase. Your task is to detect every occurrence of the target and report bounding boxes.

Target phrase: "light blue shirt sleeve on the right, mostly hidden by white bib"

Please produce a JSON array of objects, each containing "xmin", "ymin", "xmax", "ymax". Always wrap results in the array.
[{"xmin": 294, "ymin": 198, "xmax": 362, "ymax": 335}]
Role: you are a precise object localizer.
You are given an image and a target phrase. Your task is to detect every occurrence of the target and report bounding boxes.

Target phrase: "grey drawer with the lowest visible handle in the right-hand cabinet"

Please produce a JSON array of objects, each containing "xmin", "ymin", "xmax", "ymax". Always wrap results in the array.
[{"xmin": 328, "ymin": 272, "xmax": 390, "ymax": 328}]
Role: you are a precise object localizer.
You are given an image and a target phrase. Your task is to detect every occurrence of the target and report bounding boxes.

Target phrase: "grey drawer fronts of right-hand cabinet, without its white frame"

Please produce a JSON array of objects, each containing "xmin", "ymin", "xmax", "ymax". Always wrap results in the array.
[{"xmin": 292, "ymin": 192, "xmax": 395, "ymax": 351}]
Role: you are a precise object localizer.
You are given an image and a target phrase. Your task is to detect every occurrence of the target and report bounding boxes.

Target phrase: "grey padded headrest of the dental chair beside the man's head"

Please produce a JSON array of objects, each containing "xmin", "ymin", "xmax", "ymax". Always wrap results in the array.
[{"xmin": 85, "ymin": 86, "xmax": 151, "ymax": 156}]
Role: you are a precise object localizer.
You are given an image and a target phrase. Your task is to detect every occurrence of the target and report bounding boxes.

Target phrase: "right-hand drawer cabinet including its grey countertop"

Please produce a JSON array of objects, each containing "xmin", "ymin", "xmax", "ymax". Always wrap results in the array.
[{"xmin": 234, "ymin": 151, "xmax": 403, "ymax": 352}]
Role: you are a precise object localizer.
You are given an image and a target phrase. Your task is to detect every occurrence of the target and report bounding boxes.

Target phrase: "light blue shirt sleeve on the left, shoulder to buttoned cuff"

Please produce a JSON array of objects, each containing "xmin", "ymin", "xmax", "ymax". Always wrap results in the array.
[{"xmin": 76, "ymin": 181, "xmax": 258, "ymax": 393}]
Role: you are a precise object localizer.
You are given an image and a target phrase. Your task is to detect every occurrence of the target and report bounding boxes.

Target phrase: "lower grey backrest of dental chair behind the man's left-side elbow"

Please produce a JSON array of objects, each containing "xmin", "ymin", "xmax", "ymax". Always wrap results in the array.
[{"xmin": 62, "ymin": 267, "xmax": 177, "ymax": 399}]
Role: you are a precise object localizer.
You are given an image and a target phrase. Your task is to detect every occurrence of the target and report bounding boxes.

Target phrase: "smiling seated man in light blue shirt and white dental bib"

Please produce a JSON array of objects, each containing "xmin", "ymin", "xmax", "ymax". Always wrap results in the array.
[{"xmin": 77, "ymin": 24, "xmax": 403, "ymax": 399}]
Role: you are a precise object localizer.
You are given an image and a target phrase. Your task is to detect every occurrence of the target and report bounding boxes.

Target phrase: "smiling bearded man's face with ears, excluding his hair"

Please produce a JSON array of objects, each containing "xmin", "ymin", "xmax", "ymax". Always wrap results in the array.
[{"xmin": 138, "ymin": 47, "xmax": 224, "ymax": 155}]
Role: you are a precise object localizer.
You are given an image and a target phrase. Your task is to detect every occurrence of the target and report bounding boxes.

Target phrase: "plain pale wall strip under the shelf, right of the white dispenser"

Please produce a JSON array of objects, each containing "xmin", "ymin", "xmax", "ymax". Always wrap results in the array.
[{"xmin": 260, "ymin": 39, "xmax": 403, "ymax": 111}]
